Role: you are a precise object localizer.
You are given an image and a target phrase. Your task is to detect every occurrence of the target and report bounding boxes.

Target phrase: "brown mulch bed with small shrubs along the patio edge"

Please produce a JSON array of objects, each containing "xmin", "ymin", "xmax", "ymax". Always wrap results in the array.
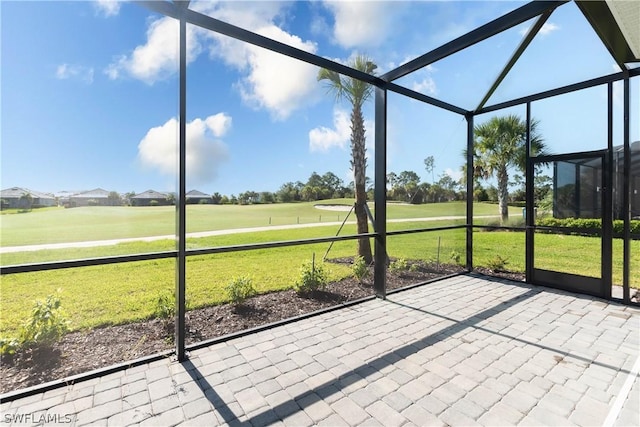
[{"xmin": 0, "ymin": 258, "xmax": 523, "ymax": 393}]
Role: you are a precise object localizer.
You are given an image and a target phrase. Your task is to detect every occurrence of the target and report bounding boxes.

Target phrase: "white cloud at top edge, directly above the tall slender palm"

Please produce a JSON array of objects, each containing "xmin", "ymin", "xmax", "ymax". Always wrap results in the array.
[{"xmin": 324, "ymin": 1, "xmax": 401, "ymax": 48}]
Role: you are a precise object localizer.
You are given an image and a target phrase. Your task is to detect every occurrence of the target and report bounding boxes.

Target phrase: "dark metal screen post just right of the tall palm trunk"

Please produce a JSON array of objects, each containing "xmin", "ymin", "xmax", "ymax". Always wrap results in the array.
[{"xmin": 373, "ymin": 88, "xmax": 387, "ymax": 299}]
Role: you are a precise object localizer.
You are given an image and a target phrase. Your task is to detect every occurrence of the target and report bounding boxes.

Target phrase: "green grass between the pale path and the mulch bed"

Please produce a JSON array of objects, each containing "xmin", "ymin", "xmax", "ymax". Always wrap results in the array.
[{"xmin": 0, "ymin": 223, "xmax": 640, "ymax": 336}]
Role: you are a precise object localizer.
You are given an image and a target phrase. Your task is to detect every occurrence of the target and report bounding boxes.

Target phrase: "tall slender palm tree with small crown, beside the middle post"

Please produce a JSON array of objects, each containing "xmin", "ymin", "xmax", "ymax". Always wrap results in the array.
[{"xmin": 318, "ymin": 55, "xmax": 378, "ymax": 264}]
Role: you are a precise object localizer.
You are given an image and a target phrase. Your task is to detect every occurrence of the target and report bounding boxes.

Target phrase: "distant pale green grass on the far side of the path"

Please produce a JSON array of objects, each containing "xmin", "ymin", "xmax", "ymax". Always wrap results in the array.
[{"xmin": 0, "ymin": 199, "xmax": 521, "ymax": 247}]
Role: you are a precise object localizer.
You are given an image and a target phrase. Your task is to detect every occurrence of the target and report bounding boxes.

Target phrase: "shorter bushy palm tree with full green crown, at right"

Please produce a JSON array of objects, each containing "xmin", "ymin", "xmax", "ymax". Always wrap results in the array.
[{"xmin": 473, "ymin": 114, "xmax": 546, "ymax": 224}]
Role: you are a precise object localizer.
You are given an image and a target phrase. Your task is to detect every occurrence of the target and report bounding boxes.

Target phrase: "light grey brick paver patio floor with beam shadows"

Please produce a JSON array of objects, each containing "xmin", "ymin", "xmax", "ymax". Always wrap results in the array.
[{"xmin": 1, "ymin": 275, "xmax": 640, "ymax": 426}]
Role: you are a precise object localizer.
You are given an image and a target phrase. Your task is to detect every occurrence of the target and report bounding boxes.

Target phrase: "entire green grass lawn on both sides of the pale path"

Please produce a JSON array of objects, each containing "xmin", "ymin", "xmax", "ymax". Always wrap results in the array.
[{"xmin": 0, "ymin": 200, "xmax": 640, "ymax": 336}]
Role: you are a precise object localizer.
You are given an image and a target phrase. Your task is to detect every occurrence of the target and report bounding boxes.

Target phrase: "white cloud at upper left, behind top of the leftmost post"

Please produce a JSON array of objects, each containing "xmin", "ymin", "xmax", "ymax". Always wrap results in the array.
[{"xmin": 105, "ymin": 17, "xmax": 201, "ymax": 85}]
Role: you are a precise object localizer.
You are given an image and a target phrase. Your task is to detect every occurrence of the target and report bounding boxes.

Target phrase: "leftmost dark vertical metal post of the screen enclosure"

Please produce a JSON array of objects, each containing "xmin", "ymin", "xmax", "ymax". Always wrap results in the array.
[{"xmin": 175, "ymin": 12, "xmax": 187, "ymax": 362}]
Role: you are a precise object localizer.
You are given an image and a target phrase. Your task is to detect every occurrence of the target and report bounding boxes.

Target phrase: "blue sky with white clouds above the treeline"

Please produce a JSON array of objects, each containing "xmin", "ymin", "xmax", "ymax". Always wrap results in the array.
[{"xmin": 0, "ymin": 1, "xmax": 640, "ymax": 195}]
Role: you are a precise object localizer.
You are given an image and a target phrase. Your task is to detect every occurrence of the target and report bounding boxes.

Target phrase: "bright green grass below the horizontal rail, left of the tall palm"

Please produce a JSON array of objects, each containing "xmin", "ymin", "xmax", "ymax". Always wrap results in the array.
[{"xmin": 0, "ymin": 243, "xmax": 352, "ymax": 335}]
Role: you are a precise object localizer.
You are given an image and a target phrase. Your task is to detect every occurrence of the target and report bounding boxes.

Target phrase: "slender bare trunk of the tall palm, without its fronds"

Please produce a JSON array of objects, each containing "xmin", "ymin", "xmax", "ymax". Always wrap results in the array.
[{"xmin": 351, "ymin": 104, "xmax": 373, "ymax": 264}]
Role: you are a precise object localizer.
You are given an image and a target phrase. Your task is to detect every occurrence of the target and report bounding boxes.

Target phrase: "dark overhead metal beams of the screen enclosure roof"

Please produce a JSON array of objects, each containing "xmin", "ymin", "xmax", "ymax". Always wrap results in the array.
[{"xmin": 141, "ymin": 0, "xmax": 640, "ymax": 110}]
